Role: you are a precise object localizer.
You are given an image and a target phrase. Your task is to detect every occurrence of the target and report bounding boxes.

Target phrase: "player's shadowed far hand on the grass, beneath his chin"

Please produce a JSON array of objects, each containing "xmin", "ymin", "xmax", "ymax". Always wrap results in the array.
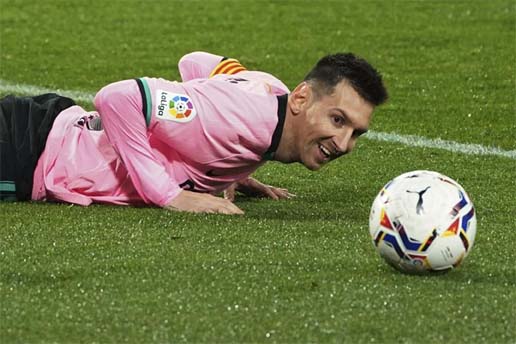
[{"xmin": 224, "ymin": 177, "xmax": 296, "ymax": 201}]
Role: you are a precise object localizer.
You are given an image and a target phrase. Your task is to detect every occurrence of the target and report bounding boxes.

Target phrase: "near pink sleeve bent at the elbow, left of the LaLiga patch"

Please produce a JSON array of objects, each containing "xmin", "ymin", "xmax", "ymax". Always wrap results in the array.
[{"xmin": 94, "ymin": 80, "xmax": 182, "ymax": 206}]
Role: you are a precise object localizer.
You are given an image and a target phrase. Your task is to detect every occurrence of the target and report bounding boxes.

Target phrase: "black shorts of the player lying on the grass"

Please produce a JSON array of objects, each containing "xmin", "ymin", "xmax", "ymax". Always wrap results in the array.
[{"xmin": 0, "ymin": 93, "xmax": 75, "ymax": 201}]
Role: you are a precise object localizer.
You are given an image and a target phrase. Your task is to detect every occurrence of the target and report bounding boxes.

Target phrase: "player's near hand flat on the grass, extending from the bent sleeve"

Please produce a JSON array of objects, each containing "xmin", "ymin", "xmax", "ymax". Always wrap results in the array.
[{"xmin": 164, "ymin": 190, "xmax": 244, "ymax": 215}]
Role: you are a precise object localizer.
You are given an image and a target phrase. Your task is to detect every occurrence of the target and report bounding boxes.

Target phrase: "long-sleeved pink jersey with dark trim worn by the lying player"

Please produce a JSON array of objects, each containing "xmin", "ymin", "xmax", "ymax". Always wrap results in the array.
[{"xmin": 32, "ymin": 52, "xmax": 288, "ymax": 206}]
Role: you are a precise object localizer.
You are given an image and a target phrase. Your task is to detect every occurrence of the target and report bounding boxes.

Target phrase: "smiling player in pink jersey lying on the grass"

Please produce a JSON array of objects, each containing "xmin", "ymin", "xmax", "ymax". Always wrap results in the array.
[{"xmin": 0, "ymin": 52, "xmax": 387, "ymax": 214}]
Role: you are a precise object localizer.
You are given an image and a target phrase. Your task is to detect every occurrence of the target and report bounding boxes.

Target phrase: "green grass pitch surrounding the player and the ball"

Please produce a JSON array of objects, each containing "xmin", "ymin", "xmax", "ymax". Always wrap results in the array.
[{"xmin": 0, "ymin": 0, "xmax": 516, "ymax": 343}]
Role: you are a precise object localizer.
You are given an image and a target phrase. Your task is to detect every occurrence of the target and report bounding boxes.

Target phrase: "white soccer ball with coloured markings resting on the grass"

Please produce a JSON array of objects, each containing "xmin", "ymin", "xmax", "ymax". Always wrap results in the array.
[{"xmin": 369, "ymin": 171, "xmax": 477, "ymax": 273}]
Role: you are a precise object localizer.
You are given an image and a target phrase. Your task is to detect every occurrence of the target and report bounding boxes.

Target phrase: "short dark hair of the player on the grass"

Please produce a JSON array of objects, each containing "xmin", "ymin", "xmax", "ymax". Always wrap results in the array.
[{"xmin": 305, "ymin": 53, "xmax": 388, "ymax": 106}]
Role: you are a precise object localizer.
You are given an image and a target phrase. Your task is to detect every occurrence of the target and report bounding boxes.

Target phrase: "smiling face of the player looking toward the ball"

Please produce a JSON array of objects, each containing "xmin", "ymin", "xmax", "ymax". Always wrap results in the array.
[{"xmin": 296, "ymin": 81, "xmax": 374, "ymax": 170}]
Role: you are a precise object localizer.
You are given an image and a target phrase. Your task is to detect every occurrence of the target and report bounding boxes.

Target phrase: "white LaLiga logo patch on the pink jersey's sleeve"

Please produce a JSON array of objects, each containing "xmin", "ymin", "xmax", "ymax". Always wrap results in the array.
[{"xmin": 156, "ymin": 90, "xmax": 197, "ymax": 123}]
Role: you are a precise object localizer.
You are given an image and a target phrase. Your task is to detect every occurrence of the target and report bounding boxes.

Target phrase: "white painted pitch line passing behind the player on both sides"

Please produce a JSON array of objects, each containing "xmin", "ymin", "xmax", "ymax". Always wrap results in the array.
[{"xmin": 0, "ymin": 80, "xmax": 516, "ymax": 160}]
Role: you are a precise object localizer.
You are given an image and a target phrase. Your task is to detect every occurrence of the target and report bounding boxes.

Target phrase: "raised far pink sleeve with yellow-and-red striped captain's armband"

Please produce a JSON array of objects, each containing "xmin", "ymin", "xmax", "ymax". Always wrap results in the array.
[{"xmin": 179, "ymin": 51, "xmax": 246, "ymax": 82}]
